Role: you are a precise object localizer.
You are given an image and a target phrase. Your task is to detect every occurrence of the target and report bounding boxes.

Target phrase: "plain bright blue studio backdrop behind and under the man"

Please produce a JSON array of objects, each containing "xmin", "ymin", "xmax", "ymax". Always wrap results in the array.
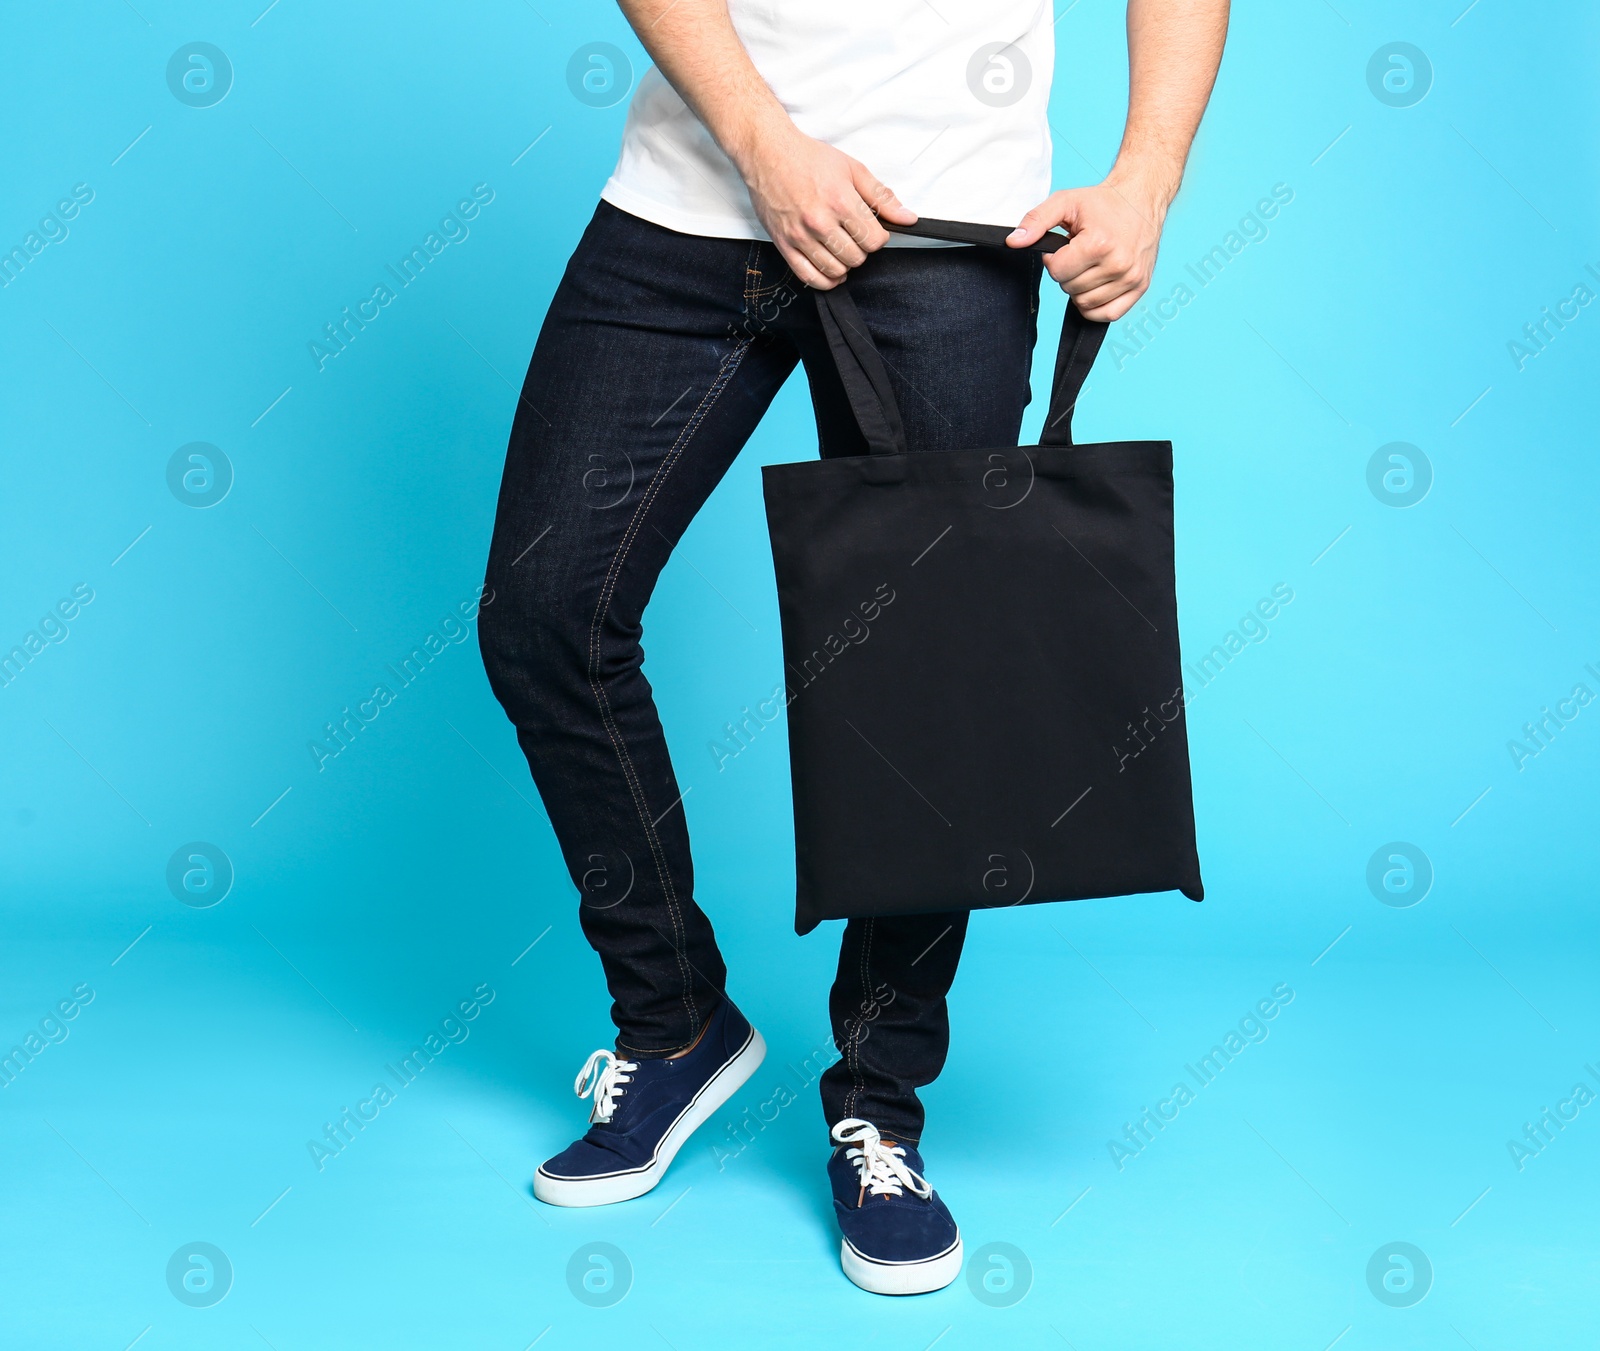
[{"xmin": 0, "ymin": 0, "xmax": 1600, "ymax": 1351}]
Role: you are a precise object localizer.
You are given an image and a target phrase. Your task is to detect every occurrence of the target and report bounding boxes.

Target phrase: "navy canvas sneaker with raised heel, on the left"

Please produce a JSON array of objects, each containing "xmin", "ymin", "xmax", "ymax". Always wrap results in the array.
[{"xmin": 533, "ymin": 999, "xmax": 766, "ymax": 1205}]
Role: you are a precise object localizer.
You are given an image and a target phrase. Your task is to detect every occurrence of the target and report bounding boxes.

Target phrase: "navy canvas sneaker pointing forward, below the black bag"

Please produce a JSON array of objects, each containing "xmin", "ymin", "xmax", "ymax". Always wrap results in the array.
[{"xmin": 827, "ymin": 1117, "xmax": 962, "ymax": 1295}]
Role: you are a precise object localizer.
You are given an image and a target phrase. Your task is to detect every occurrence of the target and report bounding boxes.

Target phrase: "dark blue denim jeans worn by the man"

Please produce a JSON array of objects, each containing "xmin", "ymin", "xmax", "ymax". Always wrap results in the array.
[{"xmin": 478, "ymin": 203, "xmax": 1040, "ymax": 1143}]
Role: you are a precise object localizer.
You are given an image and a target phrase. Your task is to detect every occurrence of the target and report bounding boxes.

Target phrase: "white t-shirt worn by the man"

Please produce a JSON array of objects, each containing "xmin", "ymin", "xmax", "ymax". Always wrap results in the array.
[{"xmin": 602, "ymin": 0, "xmax": 1054, "ymax": 243}]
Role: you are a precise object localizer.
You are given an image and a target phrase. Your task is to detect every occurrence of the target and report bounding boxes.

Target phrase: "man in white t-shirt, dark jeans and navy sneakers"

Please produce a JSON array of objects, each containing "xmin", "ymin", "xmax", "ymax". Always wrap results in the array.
[{"xmin": 480, "ymin": 0, "xmax": 1227, "ymax": 1293}]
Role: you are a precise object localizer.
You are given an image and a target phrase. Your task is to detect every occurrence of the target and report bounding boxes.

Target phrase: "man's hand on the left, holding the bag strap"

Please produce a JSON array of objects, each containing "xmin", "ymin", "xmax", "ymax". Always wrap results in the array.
[{"xmin": 742, "ymin": 126, "xmax": 917, "ymax": 291}]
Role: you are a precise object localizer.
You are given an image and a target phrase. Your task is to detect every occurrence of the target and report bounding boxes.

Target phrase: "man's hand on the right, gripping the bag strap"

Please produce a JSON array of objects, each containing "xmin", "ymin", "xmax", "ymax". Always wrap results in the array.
[{"xmin": 1006, "ymin": 179, "xmax": 1166, "ymax": 322}]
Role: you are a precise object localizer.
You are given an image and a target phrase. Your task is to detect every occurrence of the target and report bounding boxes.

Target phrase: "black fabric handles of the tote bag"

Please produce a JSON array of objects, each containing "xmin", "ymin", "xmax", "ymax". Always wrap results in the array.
[{"xmin": 816, "ymin": 216, "xmax": 1110, "ymax": 455}]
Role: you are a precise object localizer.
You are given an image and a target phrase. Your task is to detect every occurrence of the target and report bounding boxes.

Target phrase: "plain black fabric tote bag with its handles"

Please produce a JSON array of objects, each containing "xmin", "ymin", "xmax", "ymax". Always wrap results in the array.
[{"xmin": 762, "ymin": 219, "xmax": 1203, "ymax": 933}]
